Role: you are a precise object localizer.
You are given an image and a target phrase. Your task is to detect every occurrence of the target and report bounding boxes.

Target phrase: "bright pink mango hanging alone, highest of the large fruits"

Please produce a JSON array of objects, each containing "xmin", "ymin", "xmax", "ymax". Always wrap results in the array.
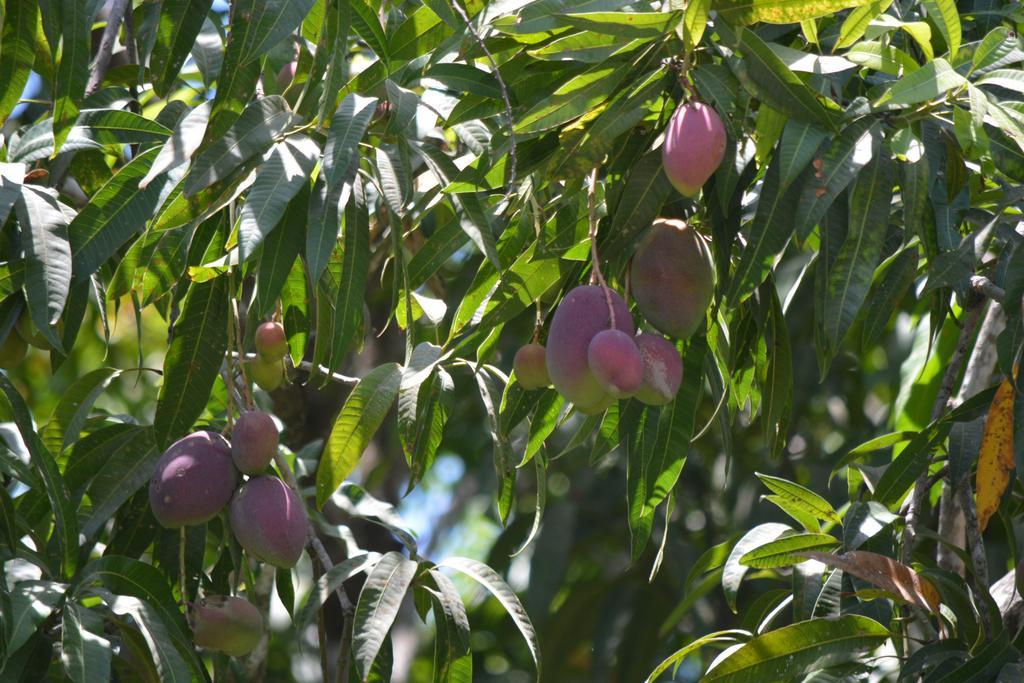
[{"xmin": 662, "ymin": 102, "xmax": 726, "ymax": 197}]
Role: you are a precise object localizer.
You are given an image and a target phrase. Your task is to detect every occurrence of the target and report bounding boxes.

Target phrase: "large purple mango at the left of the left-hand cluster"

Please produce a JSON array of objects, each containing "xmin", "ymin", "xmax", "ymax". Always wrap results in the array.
[{"xmin": 150, "ymin": 431, "xmax": 239, "ymax": 528}]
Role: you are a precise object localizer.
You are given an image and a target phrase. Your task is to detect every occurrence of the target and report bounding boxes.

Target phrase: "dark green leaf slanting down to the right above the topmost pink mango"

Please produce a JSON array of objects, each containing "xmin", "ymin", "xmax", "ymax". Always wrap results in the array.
[{"xmin": 718, "ymin": 25, "xmax": 836, "ymax": 130}]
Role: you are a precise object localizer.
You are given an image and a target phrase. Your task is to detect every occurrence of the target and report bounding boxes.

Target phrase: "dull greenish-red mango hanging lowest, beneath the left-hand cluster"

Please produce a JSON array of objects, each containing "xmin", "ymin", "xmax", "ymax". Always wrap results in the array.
[{"xmin": 191, "ymin": 595, "xmax": 263, "ymax": 657}]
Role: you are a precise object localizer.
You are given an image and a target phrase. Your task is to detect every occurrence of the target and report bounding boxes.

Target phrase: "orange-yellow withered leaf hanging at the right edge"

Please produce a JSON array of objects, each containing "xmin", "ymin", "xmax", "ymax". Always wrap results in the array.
[{"xmin": 975, "ymin": 379, "xmax": 1017, "ymax": 531}]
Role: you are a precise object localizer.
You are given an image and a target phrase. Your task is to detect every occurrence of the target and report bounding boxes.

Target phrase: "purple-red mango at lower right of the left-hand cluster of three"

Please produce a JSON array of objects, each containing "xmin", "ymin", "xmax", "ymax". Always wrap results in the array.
[{"xmin": 228, "ymin": 476, "xmax": 308, "ymax": 568}]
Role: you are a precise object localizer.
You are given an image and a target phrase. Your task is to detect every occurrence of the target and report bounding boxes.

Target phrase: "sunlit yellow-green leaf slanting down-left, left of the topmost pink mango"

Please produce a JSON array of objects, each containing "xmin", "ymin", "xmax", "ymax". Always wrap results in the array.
[{"xmin": 515, "ymin": 65, "xmax": 630, "ymax": 135}]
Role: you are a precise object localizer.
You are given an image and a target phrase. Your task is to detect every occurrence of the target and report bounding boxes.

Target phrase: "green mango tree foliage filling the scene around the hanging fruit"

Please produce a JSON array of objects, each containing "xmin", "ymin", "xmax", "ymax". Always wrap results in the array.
[{"xmin": 0, "ymin": 0, "xmax": 1024, "ymax": 681}]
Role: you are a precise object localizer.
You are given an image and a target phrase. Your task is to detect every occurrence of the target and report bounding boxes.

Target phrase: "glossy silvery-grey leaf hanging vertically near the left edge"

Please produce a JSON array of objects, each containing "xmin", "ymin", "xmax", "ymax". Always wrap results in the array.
[{"xmin": 15, "ymin": 185, "xmax": 72, "ymax": 349}]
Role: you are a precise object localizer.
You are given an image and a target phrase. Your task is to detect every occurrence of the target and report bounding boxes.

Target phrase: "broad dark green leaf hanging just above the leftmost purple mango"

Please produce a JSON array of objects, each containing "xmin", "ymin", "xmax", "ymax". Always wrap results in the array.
[{"xmin": 153, "ymin": 278, "xmax": 229, "ymax": 447}]
